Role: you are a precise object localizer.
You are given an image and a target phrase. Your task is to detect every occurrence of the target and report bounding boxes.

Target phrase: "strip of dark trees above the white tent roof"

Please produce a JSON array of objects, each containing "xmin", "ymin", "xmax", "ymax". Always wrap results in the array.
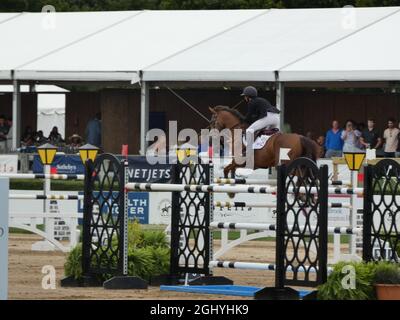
[{"xmin": 0, "ymin": 0, "xmax": 400, "ymax": 12}]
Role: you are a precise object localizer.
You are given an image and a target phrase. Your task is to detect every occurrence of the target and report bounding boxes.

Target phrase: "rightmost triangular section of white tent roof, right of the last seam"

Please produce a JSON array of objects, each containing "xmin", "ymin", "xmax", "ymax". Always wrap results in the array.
[{"xmin": 279, "ymin": 11, "xmax": 400, "ymax": 81}]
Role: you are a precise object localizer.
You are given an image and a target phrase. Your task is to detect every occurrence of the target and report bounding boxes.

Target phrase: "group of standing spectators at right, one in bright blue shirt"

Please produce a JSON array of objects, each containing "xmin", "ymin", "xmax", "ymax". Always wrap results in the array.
[{"xmin": 307, "ymin": 118, "xmax": 400, "ymax": 158}]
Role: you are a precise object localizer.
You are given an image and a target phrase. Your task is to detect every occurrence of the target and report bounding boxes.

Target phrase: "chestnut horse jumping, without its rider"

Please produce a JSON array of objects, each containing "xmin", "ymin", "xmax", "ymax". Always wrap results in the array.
[{"xmin": 210, "ymin": 106, "xmax": 319, "ymax": 178}]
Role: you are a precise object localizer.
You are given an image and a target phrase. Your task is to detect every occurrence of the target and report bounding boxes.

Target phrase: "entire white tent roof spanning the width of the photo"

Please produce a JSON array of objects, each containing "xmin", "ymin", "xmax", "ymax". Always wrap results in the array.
[{"xmin": 0, "ymin": 7, "xmax": 400, "ymax": 81}]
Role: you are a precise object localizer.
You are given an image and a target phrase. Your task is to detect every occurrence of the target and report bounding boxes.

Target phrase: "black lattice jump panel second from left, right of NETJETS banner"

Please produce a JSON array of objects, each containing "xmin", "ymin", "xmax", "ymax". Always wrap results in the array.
[{"xmin": 171, "ymin": 164, "xmax": 212, "ymax": 276}]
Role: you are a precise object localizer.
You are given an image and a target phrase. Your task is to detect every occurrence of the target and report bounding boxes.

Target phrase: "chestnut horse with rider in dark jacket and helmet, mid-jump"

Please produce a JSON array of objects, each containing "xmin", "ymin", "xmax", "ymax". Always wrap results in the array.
[{"xmin": 210, "ymin": 86, "xmax": 319, "ymax": 178}]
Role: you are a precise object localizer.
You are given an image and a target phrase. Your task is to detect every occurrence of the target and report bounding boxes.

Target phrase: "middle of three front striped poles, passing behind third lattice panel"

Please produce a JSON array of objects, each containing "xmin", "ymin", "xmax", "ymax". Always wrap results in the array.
[{"xmin": 210, "ymin": 222, "xmax": 362, "ymax": 235}]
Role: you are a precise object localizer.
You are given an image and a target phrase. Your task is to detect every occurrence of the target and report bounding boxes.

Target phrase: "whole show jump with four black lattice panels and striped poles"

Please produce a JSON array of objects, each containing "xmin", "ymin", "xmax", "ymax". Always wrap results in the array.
[{"xmin": 63, "ymin": 154, "xmax": 400, "ymax": 299}]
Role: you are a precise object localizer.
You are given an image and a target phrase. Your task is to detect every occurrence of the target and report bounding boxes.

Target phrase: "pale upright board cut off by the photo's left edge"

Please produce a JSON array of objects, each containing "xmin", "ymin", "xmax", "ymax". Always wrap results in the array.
[{"xmin": 0, "ymin": 178, "xmax": 9, "ymax": 300}]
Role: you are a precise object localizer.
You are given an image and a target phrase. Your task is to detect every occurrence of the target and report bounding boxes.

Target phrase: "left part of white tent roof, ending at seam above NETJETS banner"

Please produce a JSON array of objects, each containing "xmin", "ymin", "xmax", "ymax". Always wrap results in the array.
[{"xmin": 0, "ymin": 10, "xmax": 264, "ymax": 81}]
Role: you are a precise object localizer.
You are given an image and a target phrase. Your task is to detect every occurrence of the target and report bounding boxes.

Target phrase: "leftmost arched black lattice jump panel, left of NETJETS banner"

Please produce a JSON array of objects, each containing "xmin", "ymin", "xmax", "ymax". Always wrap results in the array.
[{"xmin": 82, "ymin": 154, "xmax": 127, "ymax": 277}]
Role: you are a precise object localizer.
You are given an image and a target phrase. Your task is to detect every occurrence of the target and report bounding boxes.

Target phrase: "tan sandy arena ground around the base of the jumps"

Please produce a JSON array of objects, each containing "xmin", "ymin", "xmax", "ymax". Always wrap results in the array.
[{"xmin": 9, "ymin": 234, "xmax": 338, "ymax": 300}]
